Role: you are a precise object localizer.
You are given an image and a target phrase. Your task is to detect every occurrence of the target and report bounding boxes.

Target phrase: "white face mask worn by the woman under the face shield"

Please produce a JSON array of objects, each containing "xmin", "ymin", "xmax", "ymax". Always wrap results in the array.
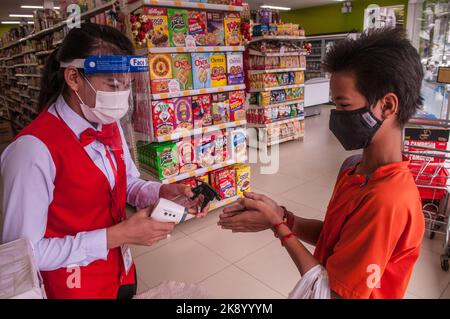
[{"xmin": 75, "ymin": 78, "xmax": 131, "ymax": 124}]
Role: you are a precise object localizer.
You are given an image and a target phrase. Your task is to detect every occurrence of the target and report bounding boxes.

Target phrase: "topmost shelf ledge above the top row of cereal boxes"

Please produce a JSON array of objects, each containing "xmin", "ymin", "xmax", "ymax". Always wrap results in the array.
[{"xmin": 123, "ymin": 0, "xmax": 243, "ymax": 14}]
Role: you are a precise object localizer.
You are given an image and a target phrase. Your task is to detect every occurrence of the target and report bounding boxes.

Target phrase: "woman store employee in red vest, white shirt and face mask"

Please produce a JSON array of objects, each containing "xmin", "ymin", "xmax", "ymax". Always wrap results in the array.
[{"xmin": 1, "ymin": 23, "xmax": 206, "ymax": 298}]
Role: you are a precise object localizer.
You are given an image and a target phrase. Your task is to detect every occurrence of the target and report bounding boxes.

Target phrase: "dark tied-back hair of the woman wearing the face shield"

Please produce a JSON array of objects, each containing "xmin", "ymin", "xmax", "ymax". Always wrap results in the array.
[{"xmin": 39, "ymin": 23, "xmax": 134, "ymax": 110}]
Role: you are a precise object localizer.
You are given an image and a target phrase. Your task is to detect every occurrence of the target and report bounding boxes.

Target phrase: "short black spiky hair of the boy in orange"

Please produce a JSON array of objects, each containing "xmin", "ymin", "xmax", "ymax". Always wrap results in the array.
[{"xmin": 323, "ymin": 28, "xmax": 423, "ymax": 125}]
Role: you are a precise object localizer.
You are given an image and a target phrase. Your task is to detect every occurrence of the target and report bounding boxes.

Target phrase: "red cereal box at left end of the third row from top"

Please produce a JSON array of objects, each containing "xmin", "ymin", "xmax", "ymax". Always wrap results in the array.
[{"xmin": 152, "ymin": 100, "xmax": 176, "ymax": 137}]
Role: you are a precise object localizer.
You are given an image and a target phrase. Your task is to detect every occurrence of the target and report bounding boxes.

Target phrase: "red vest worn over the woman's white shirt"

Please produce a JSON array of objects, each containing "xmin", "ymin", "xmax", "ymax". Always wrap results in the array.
[{"xmin": 16, "ymin": 111, "xmax": 136, "ymax": 298}]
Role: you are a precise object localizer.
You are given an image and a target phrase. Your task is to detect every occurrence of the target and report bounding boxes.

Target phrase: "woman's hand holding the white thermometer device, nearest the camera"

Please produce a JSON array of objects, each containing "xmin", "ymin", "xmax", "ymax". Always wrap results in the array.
[{"xmin": 107, "ymin": 207, "xmax": 175, "ymax": 249}]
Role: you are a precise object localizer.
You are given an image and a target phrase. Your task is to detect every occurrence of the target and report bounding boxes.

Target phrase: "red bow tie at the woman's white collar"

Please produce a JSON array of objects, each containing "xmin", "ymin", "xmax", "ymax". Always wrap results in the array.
[{"xmin": 80, "ymin": 123, "xmax": 122, "ymax": 150}]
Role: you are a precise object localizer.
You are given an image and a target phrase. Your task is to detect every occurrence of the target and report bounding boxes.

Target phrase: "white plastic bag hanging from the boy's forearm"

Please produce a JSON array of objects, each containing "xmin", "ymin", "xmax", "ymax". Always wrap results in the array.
[{"xmin": 288, "ymin": 265, "xmax": 330, "ymax": 299}]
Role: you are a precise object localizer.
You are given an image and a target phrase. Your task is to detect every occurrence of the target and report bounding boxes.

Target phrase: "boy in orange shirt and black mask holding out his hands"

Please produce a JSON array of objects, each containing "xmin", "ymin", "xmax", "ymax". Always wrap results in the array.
[{"xmin": 219, "ymin": 29, "xmax": 425, "ymax": 298}]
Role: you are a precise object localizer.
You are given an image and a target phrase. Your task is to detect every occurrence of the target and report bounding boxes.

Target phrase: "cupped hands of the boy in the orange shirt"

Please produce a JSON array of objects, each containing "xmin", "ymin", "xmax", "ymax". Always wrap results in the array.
[{"xmin": 218, "ymin": 192, "xmax": 283, "ymax": 232}]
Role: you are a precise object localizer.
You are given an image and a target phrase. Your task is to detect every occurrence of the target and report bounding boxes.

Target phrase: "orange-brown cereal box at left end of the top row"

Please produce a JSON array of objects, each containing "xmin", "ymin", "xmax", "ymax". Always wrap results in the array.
[{"xmin": 144, "ymin": 7, "xmax": 169, "ymax": 48}]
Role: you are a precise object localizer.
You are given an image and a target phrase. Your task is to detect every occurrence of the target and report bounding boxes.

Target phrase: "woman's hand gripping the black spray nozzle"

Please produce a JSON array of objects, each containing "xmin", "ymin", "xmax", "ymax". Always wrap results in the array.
[{"xmin": 159, "ymin": 184, "xmax": 209, "ymax": 218}]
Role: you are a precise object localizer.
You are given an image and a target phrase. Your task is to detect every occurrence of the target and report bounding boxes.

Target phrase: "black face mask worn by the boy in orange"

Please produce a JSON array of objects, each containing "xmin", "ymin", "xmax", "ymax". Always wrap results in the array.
[{"xmin": 329, "ymin": 106, "xmax": 383, "ymax": 151}]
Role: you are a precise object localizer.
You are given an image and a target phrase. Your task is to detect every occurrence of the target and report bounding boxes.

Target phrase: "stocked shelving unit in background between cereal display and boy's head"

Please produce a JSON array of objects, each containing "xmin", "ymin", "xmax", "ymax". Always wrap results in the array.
[{"xmin": 246, "ymin": 36, "xmax": 307, "ymax": 150}]
